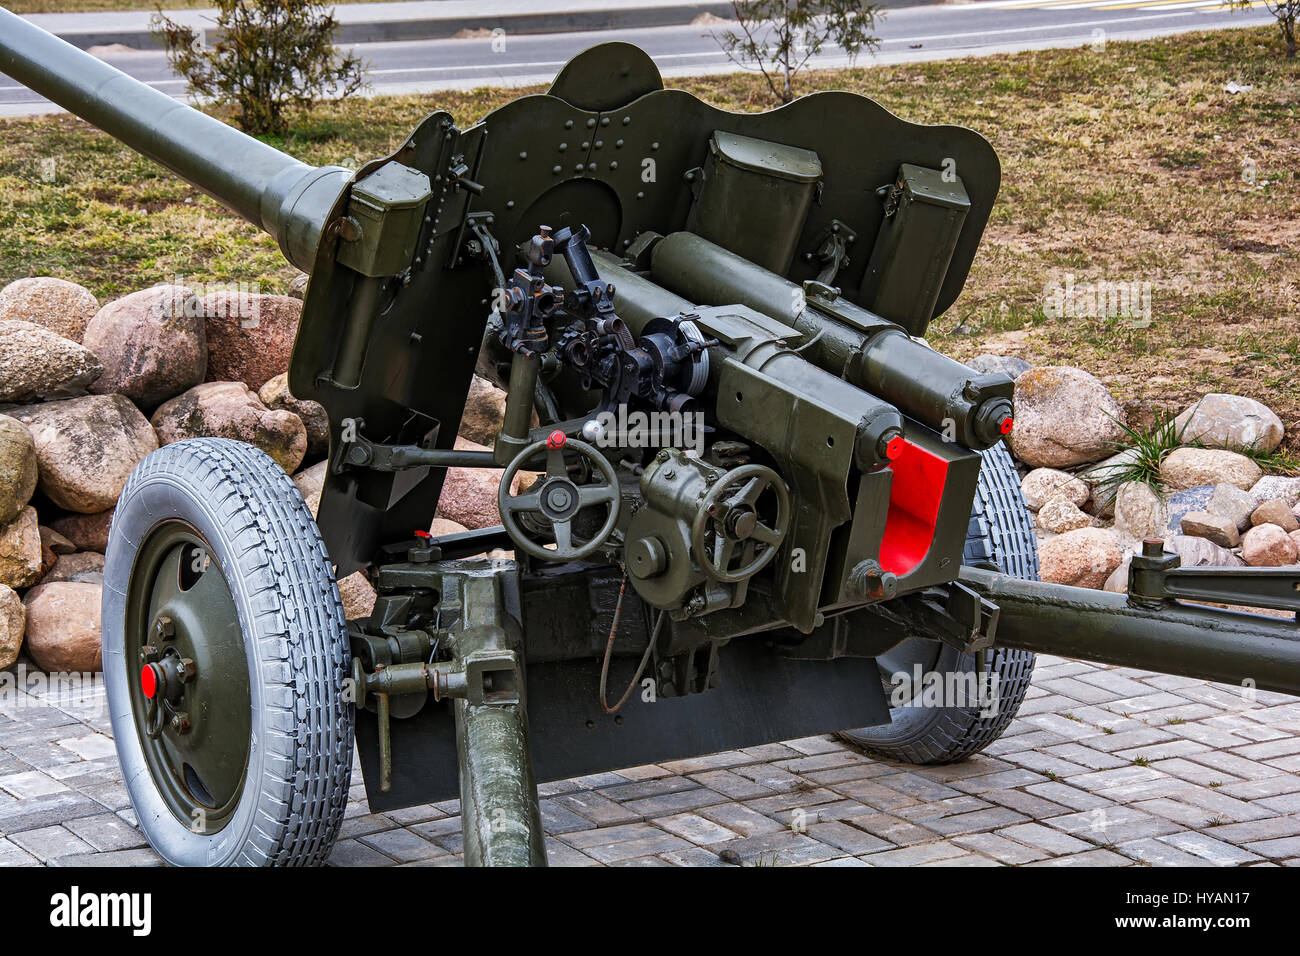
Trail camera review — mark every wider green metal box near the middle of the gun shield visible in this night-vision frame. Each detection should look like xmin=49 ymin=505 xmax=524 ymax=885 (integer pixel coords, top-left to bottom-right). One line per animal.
xmin=686 ymin=130 xmax=822 ymax=276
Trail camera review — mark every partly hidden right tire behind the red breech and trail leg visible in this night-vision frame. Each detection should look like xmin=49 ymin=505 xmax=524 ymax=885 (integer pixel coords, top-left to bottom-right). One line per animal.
xmin=841 ymin=442 xmax=1039 ymax=763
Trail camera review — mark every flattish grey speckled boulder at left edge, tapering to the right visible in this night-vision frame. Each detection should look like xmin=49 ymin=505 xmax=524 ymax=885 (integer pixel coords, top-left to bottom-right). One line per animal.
xmin=0 ymin=319 xmax=104 ymax=402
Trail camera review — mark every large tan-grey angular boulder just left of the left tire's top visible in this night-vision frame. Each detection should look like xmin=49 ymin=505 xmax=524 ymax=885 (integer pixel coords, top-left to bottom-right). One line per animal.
xmin=12 ymin=394 xmax=159 ymax=515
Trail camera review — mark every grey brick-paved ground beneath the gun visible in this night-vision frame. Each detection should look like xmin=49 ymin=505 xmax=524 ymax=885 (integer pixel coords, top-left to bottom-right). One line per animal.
xmin=0 ymin=657 xmax=1300 ymax=866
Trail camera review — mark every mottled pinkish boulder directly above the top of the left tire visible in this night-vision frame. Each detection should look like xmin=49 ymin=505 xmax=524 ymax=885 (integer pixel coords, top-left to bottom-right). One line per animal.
xmin=151 ymin=381 xmax=307 ymax=473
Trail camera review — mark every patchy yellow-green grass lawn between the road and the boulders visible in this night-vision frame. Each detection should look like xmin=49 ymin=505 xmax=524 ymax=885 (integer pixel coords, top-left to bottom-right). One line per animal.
xmin=0 ymin=27 xmax=1300 ymax=454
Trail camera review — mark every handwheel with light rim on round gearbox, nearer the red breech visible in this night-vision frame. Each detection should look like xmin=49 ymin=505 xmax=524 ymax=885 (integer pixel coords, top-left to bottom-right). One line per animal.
xmin=690 ymin=464 xmax=790 ymax=584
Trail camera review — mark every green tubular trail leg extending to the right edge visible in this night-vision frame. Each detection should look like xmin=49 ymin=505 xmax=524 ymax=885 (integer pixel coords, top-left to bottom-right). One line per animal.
xmin=961 ymin=567 xmax=1300 ymax=696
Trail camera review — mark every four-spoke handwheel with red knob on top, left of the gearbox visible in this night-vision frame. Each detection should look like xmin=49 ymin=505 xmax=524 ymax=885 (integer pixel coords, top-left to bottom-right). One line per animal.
xmin=497 ymin=431 xmax=620 ymax=561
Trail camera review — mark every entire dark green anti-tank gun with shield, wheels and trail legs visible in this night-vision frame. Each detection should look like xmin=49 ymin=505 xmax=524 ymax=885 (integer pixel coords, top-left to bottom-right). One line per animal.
xmin=0 ymin=18 xmax=1300 ymax=864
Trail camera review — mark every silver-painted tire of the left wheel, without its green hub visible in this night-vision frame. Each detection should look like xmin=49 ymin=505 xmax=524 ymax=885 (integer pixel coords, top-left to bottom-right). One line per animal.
xmin=101 ymin=438 xmax=354 ymax=866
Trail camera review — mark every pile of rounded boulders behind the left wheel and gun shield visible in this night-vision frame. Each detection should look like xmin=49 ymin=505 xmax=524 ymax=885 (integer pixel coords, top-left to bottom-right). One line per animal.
xmin=0 ymin=277 xmax=504 ymax=671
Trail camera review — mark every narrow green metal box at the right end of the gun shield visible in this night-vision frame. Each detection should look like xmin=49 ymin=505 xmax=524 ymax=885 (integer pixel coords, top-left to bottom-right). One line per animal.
xmin=859 ymin=163 xmax=971 ymax=336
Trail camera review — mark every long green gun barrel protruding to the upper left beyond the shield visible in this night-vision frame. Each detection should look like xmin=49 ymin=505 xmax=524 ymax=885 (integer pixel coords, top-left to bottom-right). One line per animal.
xmin=0 ymin=9 xmax=352 ymax=272
